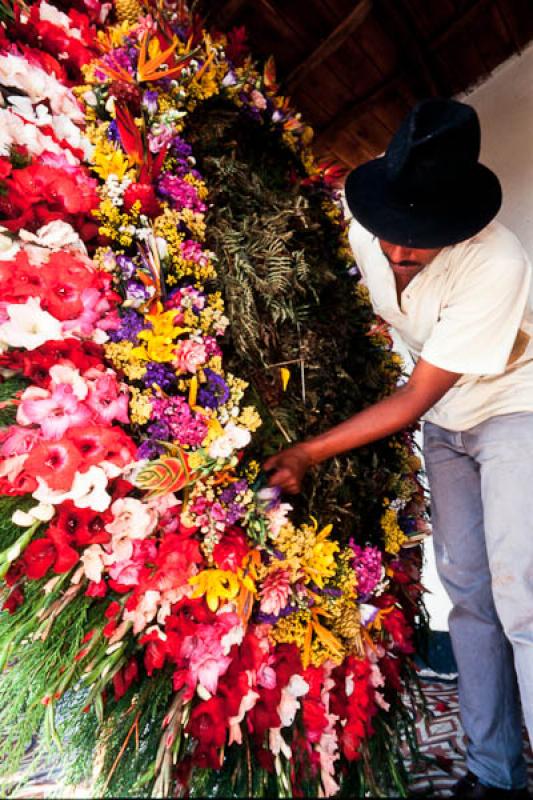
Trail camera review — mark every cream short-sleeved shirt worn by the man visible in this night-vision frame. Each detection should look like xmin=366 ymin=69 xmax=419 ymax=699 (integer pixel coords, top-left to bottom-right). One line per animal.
xmin=349 ymin=221 xmax=533 ymax=431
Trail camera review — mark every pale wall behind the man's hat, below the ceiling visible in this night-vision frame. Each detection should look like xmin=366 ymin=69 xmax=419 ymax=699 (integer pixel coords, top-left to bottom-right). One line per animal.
xmin=460 ymin=43 xmax=533 ymax=261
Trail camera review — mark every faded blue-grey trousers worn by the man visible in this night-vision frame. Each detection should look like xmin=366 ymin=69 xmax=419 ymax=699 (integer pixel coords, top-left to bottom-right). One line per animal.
xmin=424 ymin=412 xmax=533 ymax=789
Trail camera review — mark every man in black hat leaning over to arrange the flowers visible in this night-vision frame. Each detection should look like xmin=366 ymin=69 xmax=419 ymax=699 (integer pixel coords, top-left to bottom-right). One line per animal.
xmin=265 ymin=99 xmax=533 ymax=798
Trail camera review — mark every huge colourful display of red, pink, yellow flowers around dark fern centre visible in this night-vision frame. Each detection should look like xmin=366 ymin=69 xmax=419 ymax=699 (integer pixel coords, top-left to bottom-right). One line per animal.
xmin=0 ymin=0 xmax=423 ymax=796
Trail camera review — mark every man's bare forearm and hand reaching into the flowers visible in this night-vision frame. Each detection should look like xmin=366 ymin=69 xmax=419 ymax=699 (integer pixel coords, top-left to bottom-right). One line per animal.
xmin=265 ymin=359 xmax=461 ymax=494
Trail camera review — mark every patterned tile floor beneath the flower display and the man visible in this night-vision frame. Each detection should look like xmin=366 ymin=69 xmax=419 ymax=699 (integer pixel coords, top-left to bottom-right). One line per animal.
xmin=4 ymin=673 xmax=533 ymax=800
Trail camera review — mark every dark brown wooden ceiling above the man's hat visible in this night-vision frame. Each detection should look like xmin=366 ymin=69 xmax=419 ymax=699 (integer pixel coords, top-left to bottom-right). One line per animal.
xmin=197 ymin=0 xmax=533 ymax=166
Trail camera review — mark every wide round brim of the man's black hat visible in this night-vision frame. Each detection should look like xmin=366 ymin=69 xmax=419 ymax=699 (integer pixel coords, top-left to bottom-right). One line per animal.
xmin=345 ymin=157 xmax=502 ymax=248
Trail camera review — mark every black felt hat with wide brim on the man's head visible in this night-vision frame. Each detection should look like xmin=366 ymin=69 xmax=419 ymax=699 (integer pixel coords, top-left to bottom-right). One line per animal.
xmin=345 ymin=98 xmax=502 ymax=248
